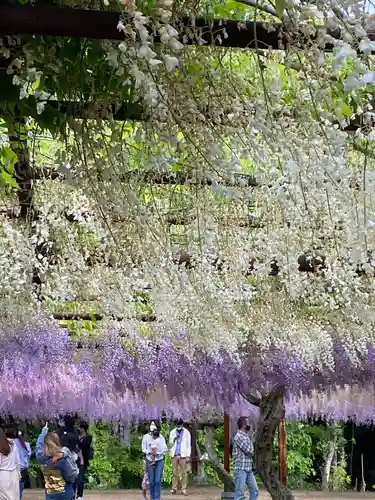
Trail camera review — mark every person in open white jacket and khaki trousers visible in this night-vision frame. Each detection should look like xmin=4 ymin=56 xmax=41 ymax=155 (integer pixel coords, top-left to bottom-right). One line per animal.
xmin=169 ymin=419 xmax=191 ymax=495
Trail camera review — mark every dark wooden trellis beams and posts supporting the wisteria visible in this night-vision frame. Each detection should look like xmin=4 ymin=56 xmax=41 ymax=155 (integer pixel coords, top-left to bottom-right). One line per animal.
xmin=0 ymin=2 xmax=374 ymax=484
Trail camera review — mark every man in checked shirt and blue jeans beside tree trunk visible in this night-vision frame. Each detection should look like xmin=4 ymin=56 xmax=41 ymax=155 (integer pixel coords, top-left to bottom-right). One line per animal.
xmin=233 ymin=417 xmax=259 ymax=500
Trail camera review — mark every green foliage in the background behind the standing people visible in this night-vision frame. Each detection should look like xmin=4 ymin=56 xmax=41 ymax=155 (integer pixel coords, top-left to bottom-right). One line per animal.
xmin=23 ymin=422 xmax=350 ymax=491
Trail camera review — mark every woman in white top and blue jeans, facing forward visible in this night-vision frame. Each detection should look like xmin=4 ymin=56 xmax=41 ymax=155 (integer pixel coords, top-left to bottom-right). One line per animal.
xmin=142 ymin=422 xmax=168 ymax=500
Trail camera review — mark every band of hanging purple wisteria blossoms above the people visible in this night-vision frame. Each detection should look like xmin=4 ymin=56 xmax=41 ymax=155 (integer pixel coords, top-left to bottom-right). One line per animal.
xmin=0 ymin=320 xmax=375 ymax=421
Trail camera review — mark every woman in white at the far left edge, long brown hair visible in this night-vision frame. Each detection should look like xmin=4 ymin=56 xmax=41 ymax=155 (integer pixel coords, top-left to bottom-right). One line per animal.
xmin=0 ymin=428 xmax=21 ymax=500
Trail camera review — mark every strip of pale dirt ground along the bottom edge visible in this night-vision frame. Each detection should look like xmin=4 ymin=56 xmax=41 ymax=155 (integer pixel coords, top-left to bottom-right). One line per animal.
xmin=24 ymin=488 xmax=375 ymax=500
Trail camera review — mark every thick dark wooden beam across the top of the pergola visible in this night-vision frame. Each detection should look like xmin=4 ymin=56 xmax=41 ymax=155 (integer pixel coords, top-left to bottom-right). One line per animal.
xmin=0 ymin=3 xmax=288 ymax=49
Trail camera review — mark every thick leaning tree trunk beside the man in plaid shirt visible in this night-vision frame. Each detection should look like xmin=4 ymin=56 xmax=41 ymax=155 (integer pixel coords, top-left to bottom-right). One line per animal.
xmin=254 ymin=387 xmax=294 ymax=500
